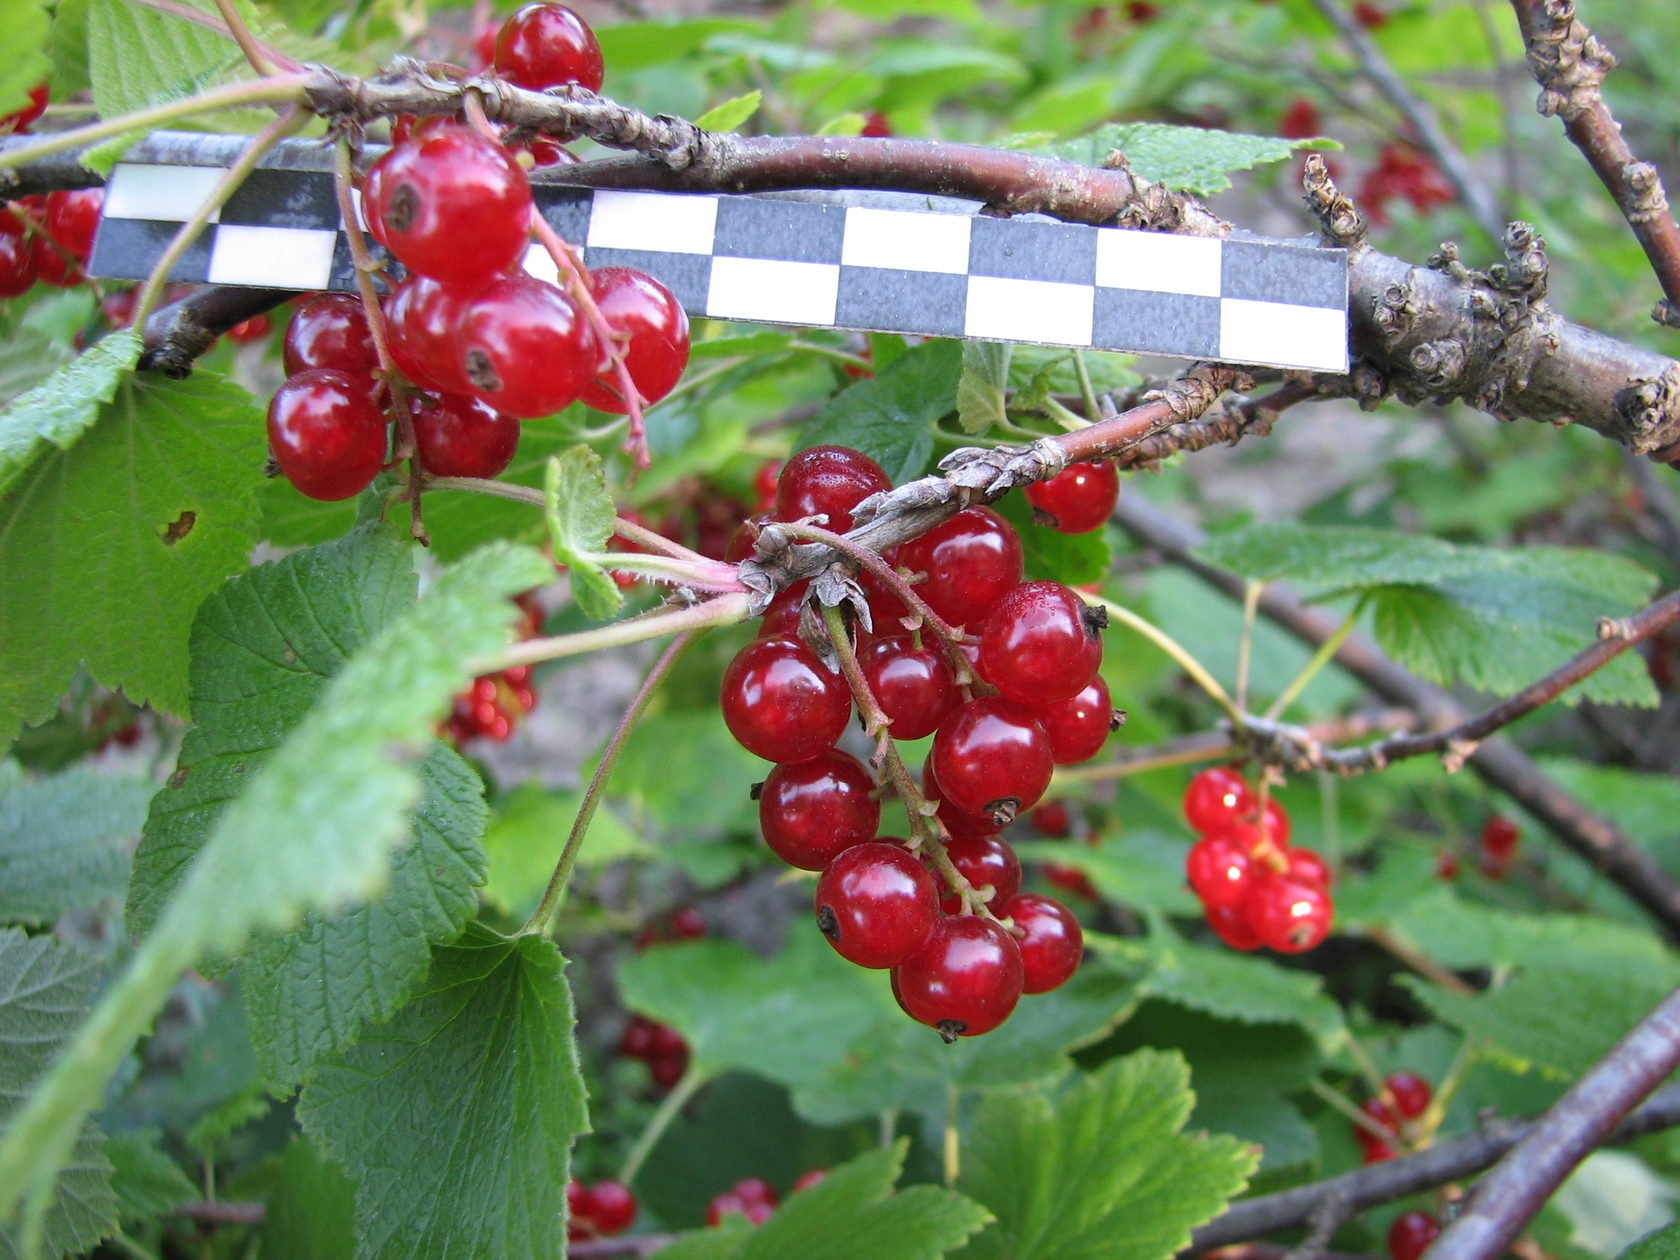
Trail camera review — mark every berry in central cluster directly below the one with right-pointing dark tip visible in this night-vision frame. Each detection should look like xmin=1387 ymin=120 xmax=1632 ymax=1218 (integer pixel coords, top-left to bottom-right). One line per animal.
xmin=931 ymin=696 xmax=1055 ymax=827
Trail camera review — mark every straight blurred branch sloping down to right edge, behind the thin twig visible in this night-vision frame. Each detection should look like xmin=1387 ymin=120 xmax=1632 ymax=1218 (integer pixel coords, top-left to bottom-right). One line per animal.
xmin=1114 ymin=496 xmax=1680 ymax=936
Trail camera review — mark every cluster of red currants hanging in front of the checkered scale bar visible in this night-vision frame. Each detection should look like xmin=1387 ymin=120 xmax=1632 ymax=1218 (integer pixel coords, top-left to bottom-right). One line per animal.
xmin=269 ymin=3 xmax=689 ymax=499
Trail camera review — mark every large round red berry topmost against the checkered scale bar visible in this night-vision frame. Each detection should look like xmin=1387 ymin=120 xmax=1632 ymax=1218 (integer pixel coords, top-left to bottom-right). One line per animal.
xmin=371 ymin=126 xmax=531 ymax=284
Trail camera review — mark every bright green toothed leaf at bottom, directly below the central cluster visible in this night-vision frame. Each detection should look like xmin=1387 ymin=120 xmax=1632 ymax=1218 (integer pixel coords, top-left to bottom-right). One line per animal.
xmin=958 ymin=1050 xmax=1258 ymax=1260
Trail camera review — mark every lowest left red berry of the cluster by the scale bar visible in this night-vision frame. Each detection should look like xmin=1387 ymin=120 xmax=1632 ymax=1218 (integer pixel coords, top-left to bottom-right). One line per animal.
xmin=269 ymin=368 xmax=386 ymax=501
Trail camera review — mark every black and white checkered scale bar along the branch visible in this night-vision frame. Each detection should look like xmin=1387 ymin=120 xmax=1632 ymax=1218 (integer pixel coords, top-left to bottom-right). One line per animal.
xmin=89 ymin=136 xmax=1347 ymax=371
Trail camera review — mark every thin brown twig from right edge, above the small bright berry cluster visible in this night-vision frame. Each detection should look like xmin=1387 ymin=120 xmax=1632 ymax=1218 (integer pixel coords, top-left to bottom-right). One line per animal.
xmin=1252 ymin=591 xmax=1680 ymax=774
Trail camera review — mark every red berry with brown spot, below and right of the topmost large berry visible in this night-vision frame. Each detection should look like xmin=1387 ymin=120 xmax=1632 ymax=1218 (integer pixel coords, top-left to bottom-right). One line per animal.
xmin=459 ymin=276 xmax=598 ymax=420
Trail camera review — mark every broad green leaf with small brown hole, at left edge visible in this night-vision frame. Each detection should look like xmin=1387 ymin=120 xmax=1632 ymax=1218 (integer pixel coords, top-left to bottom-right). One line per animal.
xmin=0 ymin=373 xmax=267 ymax=746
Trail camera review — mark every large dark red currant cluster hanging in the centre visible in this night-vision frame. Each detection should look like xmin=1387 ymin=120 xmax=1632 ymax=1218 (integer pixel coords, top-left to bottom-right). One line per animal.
xmin=722 ymin=447 xmax=1114 ymax=1040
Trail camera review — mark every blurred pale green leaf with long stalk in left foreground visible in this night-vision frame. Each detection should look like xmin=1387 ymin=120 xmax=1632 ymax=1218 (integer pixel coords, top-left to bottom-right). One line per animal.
xmin=0 ymin=548 xmax=548 ymax=1243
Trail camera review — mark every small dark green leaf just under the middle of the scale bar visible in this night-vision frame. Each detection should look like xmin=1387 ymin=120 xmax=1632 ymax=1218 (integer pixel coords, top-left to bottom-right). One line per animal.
xmin=798 ymin=341 xmax=963 ymax=486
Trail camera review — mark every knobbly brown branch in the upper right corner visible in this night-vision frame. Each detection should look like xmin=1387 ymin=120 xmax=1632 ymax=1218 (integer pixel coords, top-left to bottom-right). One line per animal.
xmin=1510 ymin=0 xmax=1680 ymax=328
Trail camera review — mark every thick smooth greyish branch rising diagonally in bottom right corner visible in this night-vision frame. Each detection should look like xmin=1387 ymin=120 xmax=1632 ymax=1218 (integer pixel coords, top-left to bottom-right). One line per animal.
xmin=1430 ymin=990 xmax=1680 ymax=1260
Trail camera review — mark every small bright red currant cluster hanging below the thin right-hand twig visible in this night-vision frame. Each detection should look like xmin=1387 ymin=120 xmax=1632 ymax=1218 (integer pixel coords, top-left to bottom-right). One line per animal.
xmin=1184 ymin=766 xmax=1334 ymax=954
